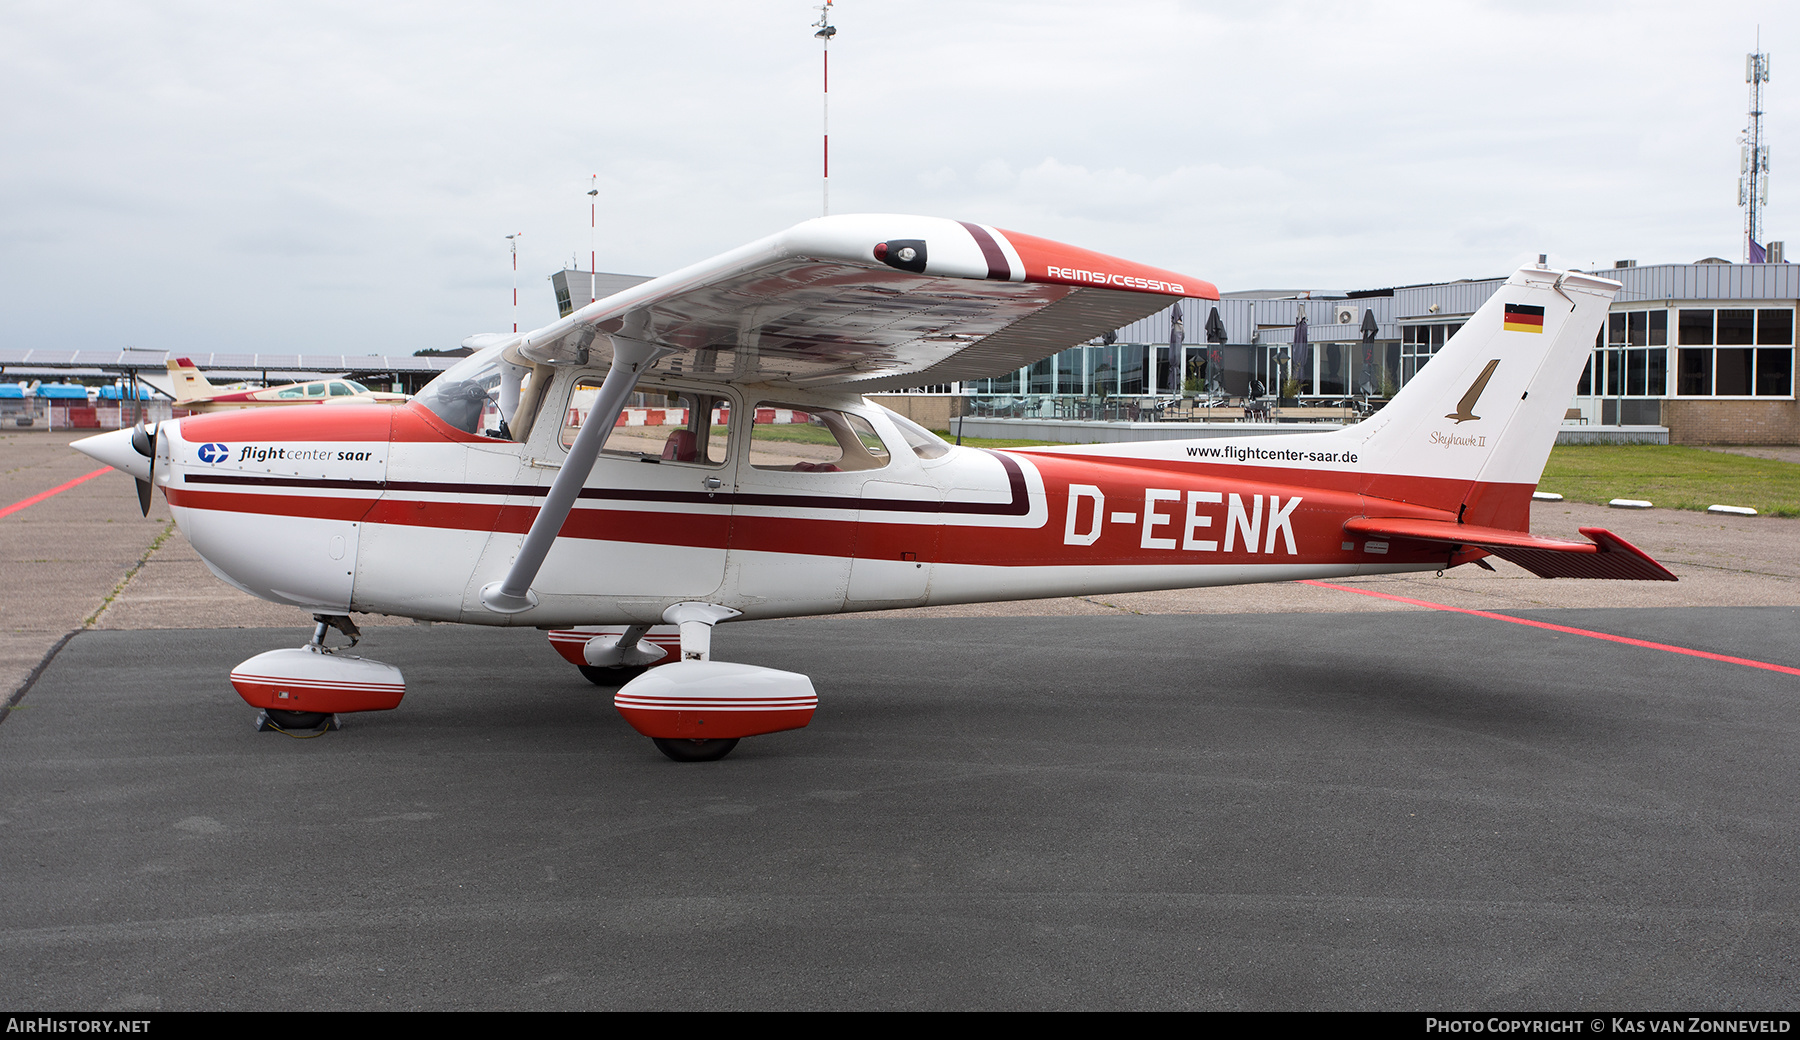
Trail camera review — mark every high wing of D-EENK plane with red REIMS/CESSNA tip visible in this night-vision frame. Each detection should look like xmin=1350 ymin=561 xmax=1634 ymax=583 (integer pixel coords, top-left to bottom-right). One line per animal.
xmin=500 ymin=214 xmax=1219 ymax=392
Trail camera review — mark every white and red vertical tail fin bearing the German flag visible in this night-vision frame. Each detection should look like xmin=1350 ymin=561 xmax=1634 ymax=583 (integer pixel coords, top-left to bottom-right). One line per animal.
xmin=1345 ymin=268 xmax=1620 ymax=531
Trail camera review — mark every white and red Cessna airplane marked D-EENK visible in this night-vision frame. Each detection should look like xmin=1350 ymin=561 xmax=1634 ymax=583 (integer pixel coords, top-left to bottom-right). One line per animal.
xmin=77 ymin=216 xmax=1674 ymax=761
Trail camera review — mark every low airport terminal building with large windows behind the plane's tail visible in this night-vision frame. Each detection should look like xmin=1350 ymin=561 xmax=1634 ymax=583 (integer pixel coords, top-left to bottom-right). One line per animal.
xmin=931 ymin=259 xmax=1800 ymax=444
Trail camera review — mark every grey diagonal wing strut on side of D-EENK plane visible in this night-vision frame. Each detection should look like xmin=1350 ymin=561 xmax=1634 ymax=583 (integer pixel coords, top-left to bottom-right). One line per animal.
xmin=481 ymin=336 xmax=673 ymax=614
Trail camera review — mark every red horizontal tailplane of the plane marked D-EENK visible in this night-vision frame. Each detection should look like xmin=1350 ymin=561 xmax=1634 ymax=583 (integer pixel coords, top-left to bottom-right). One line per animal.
xmin=1345 ymin=516 xmax=1676 ymax=581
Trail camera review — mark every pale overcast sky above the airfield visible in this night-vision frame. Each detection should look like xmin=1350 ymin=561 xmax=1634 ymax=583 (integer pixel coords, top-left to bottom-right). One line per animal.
xmin=0 ymin=0 xmax=1800 ymax=354
